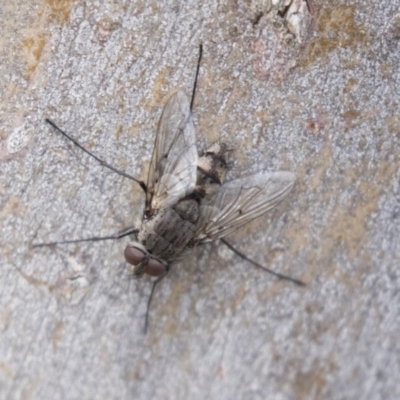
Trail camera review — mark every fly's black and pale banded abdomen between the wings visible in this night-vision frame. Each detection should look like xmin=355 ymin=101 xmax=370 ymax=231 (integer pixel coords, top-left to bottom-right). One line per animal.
xmin=194 ymin=142 xmax=228 ymax=198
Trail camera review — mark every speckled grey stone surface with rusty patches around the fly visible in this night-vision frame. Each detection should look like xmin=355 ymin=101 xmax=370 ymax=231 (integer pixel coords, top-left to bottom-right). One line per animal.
xmin=0 ymin=0 xmax=400 ymax=400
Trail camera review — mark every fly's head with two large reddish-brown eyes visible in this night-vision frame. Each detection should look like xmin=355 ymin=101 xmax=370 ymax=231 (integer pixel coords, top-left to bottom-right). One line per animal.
xmin=124 ymin=243 xmax=168 ymax=278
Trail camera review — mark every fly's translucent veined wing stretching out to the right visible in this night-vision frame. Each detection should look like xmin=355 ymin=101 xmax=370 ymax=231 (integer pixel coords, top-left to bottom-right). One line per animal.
xmin=195 ymin=172 xmax=295 ymax=244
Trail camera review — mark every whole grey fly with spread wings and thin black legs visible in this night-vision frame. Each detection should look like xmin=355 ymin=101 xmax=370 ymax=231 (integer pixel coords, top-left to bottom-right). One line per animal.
xmin=34 ymin=46 xmax=304 ymax=331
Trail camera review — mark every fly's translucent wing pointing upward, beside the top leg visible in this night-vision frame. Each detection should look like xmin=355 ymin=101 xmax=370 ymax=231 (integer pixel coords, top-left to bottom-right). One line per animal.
xmin=146 ymin=91 xmax=198 ymax=210
